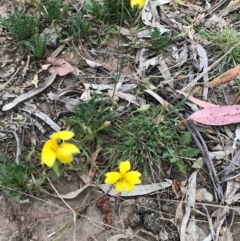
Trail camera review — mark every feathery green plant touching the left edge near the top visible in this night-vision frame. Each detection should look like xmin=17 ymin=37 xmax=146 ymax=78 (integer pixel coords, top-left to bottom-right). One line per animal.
xmin=0 ymin=11 xmax=39 ymax=42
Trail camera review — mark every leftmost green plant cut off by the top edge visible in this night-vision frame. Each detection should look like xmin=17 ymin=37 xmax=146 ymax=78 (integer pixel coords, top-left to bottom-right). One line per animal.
xmin=35 ymin=0 xmax=62 ymax=22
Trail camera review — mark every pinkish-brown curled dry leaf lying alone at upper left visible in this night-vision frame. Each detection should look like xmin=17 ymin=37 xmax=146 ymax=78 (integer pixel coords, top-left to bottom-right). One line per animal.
xmin=47 ymin=57 xmax=75 ymax=76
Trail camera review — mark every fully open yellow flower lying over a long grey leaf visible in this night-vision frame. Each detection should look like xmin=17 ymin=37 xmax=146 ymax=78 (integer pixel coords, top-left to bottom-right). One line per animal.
xmin=105 ymin=161 xmax=141 ymax=192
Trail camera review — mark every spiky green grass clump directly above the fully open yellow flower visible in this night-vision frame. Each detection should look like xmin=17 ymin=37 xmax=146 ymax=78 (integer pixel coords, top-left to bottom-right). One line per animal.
xmin=109 ymin=110 xmax=198 ymax=172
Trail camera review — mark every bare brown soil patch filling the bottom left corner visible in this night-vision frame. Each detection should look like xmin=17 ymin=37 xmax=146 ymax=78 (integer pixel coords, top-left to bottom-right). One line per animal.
xmin=0 ymin=181 xmax=125 ymax=241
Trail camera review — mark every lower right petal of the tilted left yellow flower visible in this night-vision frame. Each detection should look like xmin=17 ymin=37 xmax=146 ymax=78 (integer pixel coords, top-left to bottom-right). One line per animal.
xmin=56 ymin=143 xmax=79 ymax=163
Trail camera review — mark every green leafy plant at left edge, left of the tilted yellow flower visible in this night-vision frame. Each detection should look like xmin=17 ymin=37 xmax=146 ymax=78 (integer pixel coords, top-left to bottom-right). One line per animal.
xmin=0 ymin=152 xmax=34 ymax=199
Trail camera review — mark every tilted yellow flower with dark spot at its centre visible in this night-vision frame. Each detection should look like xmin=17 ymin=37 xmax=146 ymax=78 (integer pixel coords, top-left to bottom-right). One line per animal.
xmin=41 ymin=131 xmax=80 ymax=167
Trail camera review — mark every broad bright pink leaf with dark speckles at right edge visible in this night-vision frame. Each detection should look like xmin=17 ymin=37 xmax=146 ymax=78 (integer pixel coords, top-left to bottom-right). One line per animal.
xmin=188 ymin=105 xmax=240 ymax=126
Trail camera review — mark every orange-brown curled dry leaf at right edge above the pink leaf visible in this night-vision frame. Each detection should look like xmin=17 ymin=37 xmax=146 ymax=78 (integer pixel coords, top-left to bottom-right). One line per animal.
xmin=204 ymin=65 xmax=240 ymax=88
